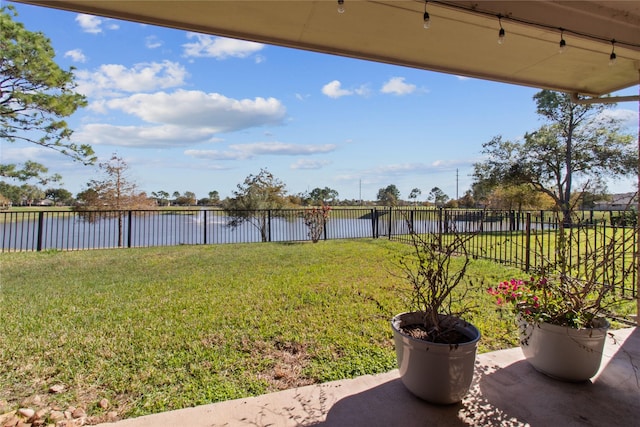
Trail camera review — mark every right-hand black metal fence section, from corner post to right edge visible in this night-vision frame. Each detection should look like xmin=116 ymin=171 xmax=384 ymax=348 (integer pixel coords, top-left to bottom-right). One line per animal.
xmin=388 ymin=209 xmax=638 ymax=298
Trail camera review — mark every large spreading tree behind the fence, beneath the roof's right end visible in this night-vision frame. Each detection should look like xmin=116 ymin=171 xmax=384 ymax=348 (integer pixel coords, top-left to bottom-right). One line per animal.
xmin=474 ymin=90 xmax=638 ymax=222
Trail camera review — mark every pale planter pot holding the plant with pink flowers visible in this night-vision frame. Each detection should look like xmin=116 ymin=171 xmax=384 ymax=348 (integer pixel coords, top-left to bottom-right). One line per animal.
xmin=518 ymin=316 xmax=609 ymax=382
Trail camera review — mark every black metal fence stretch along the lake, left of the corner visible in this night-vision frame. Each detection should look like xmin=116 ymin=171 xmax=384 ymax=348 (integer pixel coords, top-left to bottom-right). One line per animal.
xmin=0 ymin=208 xmax=386 ymax=252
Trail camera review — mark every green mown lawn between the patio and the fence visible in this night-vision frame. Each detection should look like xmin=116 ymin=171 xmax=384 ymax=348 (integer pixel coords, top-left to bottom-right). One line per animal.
xmin=0 ymin=239 xmax=632 ymax=420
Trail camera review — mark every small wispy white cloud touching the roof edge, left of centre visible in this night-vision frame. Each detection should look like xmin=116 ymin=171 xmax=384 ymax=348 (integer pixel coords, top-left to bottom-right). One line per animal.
xmin=182 ymin=33 xmax=265 ymax=62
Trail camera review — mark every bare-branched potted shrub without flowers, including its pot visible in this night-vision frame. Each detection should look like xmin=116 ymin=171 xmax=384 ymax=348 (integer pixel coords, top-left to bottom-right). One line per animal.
xmin=391 ymin=222 xmax=480 ymax=404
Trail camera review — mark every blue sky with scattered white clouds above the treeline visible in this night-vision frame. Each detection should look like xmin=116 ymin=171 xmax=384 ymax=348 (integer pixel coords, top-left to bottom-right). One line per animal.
xmin=1 ymin=4 xmax=638 ymax=200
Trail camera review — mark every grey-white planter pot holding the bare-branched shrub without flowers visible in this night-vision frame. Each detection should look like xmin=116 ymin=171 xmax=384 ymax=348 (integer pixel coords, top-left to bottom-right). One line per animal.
xmin=391 ymin=312 xmax=480 ymax=404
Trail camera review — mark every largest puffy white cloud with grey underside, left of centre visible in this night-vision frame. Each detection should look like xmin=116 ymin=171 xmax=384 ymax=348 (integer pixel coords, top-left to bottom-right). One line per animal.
xmin=106 ymin=90 xmax=286 ymax=132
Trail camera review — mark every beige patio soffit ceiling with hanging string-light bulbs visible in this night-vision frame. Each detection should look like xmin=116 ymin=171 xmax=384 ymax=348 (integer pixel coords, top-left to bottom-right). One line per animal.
xmin=10 ymin=0 xmax=640 ymax=96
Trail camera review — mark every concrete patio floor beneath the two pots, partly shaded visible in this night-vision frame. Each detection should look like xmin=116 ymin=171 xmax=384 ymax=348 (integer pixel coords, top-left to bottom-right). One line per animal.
xmin=100 ymin=328 xmax=640 ymax=427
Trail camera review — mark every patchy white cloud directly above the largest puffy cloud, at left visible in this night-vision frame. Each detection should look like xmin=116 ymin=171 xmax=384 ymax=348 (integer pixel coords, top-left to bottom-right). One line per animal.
xmin=76 ymin=61 xmax=188 ymax=96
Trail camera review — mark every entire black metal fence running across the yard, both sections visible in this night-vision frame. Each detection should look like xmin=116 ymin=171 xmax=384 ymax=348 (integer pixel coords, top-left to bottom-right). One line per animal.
xmin=0 ymin=208 xmax=637 ymax=296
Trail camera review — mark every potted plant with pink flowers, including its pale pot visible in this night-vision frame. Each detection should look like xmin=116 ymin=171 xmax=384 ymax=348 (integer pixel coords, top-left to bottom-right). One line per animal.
xmin=488 ymin=214 xmax=635 ymax=382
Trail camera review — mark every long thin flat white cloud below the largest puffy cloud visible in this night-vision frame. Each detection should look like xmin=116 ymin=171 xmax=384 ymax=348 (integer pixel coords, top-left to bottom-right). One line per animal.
xmin=185 ymin=142 xmax=336 ymax=160
